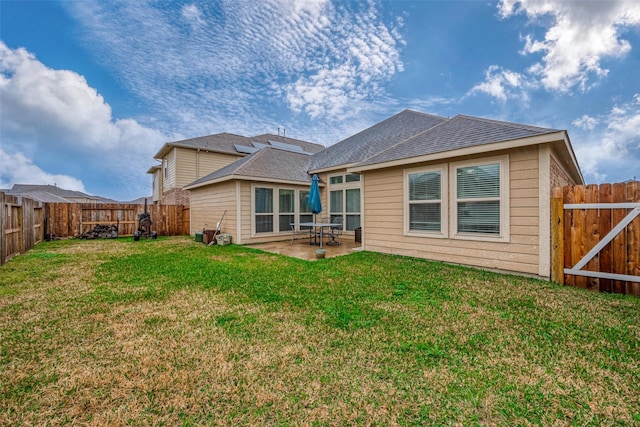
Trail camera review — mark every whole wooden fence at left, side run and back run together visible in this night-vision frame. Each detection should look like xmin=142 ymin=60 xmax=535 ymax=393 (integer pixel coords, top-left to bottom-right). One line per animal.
xmin=0 ymin=192 xmax=190 ymax=265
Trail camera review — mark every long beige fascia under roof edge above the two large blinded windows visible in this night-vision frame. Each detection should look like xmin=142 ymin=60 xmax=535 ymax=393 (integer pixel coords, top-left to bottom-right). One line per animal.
xmin=347 ymin=131 xmax=568 ymax=173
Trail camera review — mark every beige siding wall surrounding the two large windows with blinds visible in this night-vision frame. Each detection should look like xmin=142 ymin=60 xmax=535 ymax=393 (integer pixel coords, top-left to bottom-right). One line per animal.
xmin=363 ymin=147 xmax=539 ymax=274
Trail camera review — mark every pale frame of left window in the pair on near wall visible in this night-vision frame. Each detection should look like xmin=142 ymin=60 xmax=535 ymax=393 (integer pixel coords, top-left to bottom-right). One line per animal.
xmin=403 ymin=164 xmax=449 ymax=239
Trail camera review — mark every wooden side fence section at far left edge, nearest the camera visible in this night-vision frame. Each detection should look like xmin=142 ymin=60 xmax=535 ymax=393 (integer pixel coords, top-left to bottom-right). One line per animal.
xmin=0 ymin=192 xmax=43 ymax=265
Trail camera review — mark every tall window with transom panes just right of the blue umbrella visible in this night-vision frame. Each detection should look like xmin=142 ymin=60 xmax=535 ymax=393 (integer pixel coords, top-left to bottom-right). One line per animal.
xmin=329 ymin=173 xmax=362 ymax=231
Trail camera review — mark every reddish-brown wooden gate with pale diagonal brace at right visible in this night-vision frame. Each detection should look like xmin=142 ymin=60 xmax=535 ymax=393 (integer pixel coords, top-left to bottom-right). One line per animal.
xmin=551 ymin=181 xmax=640 ymax=296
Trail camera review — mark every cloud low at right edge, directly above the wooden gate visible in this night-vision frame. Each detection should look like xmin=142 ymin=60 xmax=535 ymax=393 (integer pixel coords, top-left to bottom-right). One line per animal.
xmin=573 ymin=95 xmax=640 ymax=182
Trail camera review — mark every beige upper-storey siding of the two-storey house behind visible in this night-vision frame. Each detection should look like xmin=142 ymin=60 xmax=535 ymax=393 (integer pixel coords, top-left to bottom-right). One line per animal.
xmin=174 ymin=148 xmax=240 ymax=188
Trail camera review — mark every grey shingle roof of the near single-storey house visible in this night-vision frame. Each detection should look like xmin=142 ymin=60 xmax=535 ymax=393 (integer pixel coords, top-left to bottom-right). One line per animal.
xmin=180 ymin=110 xmax=559 ymax=188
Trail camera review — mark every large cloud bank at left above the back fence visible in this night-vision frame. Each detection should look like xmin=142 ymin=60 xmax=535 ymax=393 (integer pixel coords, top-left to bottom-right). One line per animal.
xmin=0 ymin=42 xmax=166 ymax=198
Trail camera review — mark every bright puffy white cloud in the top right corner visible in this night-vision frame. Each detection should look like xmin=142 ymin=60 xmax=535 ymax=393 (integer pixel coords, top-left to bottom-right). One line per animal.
xmin=498 ymin=0 xmax=640 ymax=92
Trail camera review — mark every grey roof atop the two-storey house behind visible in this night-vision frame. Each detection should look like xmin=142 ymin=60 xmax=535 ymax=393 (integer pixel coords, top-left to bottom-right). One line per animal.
xmin=153 ymin=132 xmax=324 ymax=160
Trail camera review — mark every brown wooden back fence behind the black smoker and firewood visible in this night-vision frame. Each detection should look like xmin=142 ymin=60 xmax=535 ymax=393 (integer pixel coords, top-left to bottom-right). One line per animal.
xmin=45 ymin=203 xmax=189 ymax=238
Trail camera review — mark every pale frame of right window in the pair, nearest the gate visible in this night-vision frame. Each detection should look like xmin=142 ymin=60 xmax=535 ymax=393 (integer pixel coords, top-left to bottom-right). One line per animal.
xmin=449 ymin=154 xmax=510 ymax=242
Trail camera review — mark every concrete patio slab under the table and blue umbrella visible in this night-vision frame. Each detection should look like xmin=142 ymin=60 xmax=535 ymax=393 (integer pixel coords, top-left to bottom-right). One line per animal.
xmin=247 ymin=235 xmax=362 ymax=261
